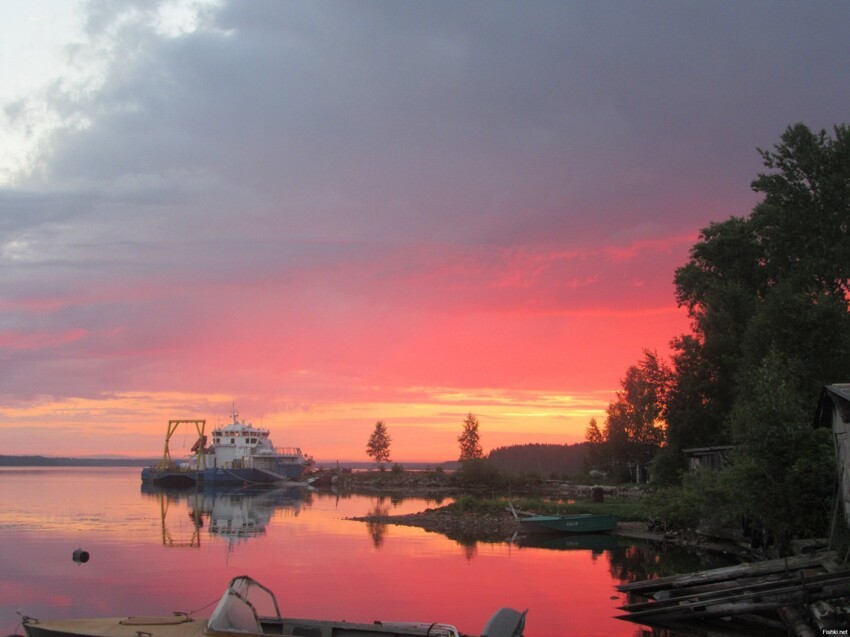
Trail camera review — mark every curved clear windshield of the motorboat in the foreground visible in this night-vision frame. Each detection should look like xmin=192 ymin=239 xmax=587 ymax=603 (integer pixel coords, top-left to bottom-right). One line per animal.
xmin=207 ymin=575 xmax=280 ymax=634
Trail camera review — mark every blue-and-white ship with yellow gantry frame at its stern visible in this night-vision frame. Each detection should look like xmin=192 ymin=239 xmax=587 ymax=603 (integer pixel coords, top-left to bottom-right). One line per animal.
xmin=142 ymin=408 xmax=313 ymax=487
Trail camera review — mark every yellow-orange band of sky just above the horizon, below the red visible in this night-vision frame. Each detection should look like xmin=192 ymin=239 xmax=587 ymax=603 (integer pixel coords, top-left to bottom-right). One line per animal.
xmin=0 ymin=388 xmax=612 ymax=463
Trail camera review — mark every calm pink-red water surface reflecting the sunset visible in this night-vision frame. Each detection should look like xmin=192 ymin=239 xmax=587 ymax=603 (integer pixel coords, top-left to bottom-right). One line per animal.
xmin=0 ymin=468 xmax=728 ymax=637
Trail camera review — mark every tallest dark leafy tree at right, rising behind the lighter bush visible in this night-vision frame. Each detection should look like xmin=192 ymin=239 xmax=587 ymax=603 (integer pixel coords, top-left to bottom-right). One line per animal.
xmin=666 ymin=124 xmax=850 ymax=458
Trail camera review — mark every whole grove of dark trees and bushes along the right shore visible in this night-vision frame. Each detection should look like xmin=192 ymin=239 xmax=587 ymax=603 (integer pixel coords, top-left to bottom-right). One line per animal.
xmin=586 ymin=124 xmax=850 ymax=548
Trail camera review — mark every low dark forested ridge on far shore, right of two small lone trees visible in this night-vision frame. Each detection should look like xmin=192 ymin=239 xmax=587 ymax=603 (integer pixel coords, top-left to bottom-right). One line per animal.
xmin=487 ymin=442 xmax=590 ymax=477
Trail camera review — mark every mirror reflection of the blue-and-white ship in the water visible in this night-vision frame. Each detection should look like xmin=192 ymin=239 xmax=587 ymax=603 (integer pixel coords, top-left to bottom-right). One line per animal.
xmin=142 ymin=483 xmax=312 ymax=547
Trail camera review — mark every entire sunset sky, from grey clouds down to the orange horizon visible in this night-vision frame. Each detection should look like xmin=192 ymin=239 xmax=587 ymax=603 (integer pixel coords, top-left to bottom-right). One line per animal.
xmin=0 ymin=0 xmax=850 ymax=462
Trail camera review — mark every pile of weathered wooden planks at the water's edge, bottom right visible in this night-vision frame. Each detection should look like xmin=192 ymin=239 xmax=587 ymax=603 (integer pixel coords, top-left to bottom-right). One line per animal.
xmin=617 ymin=551 xmax=850 ymax=637
